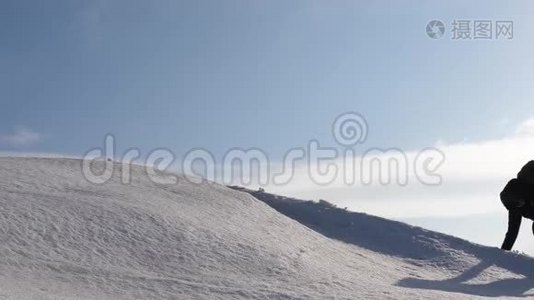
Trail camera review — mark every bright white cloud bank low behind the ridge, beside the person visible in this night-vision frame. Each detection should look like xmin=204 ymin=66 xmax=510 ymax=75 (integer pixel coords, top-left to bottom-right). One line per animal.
xmin=267 ymin=118 xmax=534 ymax=218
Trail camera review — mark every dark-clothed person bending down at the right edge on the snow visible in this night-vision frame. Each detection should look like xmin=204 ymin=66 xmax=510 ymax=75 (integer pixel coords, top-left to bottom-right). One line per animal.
xmin=500 ymin=160 xmax=534 ymax=250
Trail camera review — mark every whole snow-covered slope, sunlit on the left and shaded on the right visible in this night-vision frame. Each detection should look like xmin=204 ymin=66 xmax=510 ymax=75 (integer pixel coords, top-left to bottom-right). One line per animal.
xmin=0 ymin=158 xmax=534 ymax=299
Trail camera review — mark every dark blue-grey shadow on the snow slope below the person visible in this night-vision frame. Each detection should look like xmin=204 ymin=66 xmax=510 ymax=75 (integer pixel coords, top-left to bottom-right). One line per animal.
xmin=231 ymin=186 xmax=534 ymax=297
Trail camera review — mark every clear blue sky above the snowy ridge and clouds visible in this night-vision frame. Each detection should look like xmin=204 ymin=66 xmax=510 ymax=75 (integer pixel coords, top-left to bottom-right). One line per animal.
xmin=0 ymin=0 xmax=534 ymax=253
